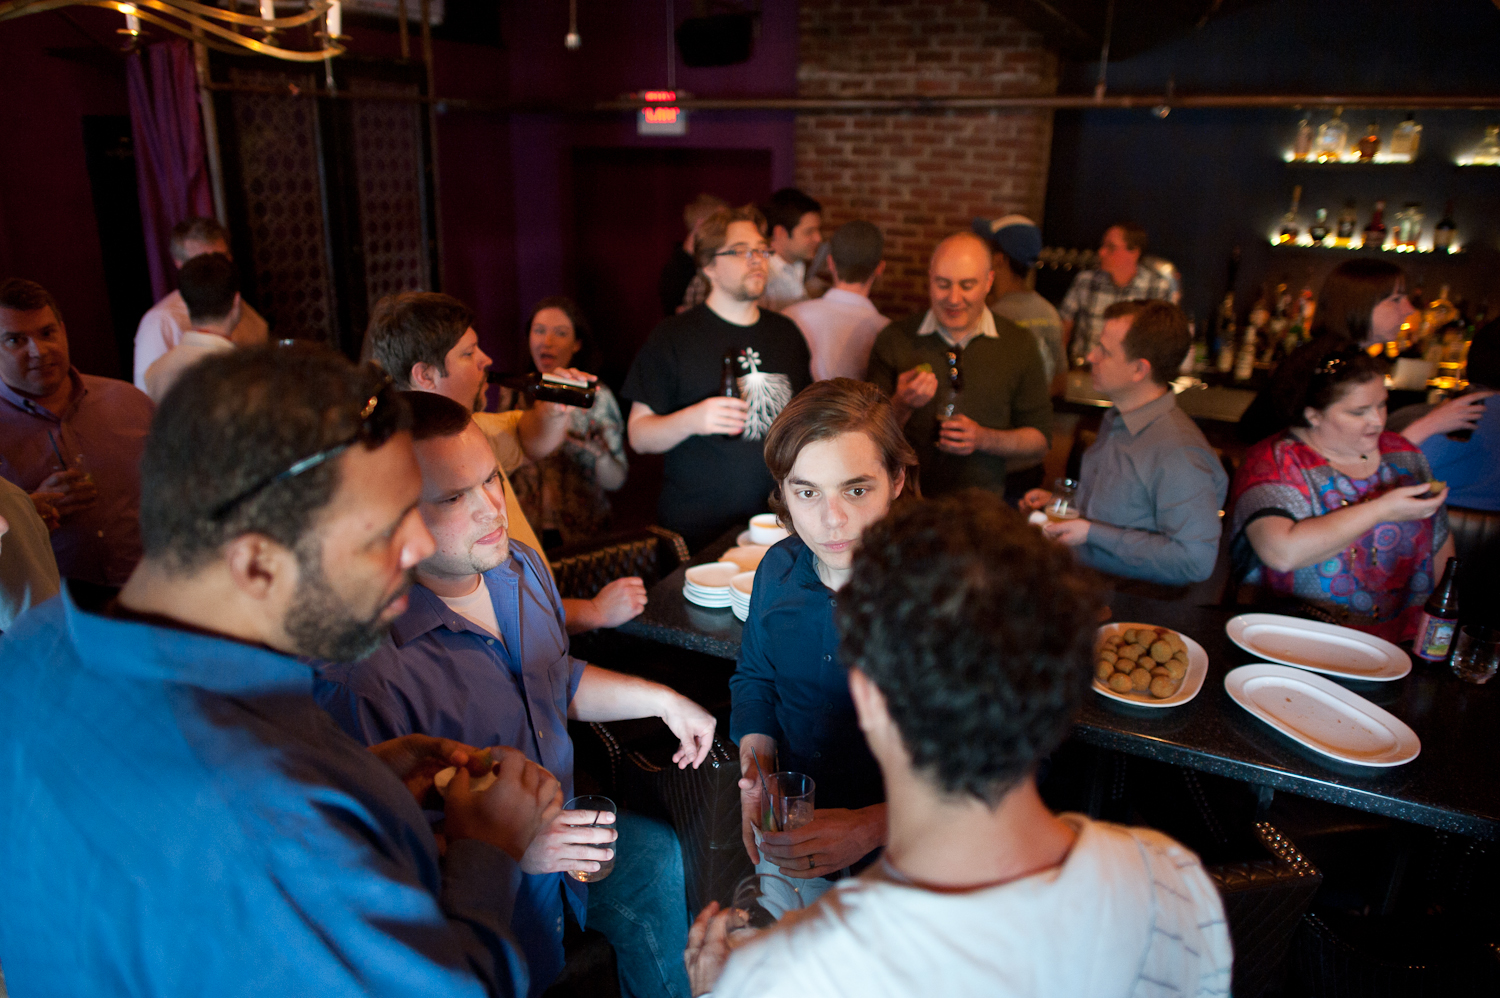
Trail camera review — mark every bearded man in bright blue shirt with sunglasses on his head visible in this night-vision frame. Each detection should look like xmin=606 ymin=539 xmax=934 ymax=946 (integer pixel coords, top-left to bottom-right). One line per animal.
xmin=0 ymin=348 xmax=561 ymax=998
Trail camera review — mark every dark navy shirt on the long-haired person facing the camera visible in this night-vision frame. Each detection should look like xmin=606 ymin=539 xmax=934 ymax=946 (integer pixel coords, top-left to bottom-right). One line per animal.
xmin=729 ymin=534 xmax=885 ymax=807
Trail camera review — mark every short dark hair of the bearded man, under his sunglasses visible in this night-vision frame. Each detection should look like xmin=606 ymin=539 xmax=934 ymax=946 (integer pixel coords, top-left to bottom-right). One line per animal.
xmin=141 ymin=342 xmax=411 ymax=572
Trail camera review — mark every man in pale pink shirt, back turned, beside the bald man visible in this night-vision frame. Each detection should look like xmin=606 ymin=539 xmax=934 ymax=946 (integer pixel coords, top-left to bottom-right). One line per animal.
xmin=782 ymin=221 xmax=891 ymax=381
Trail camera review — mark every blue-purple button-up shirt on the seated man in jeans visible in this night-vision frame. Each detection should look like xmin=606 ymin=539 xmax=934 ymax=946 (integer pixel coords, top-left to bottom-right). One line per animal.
xmin=317 ymin=540 xmax=588 ymax=993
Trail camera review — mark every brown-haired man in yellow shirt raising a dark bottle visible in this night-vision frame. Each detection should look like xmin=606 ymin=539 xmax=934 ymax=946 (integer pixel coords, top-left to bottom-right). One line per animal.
xmin=365 ymin=291 xmax=647 ymax=635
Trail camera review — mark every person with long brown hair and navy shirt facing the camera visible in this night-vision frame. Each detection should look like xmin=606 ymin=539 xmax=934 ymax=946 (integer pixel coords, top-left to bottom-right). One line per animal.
xmin=729 ymin=378 xmax=920 ymax=903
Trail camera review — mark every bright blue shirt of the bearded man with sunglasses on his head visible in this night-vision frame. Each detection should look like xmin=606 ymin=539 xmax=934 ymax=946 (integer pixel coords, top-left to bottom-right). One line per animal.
xmin=0 ymin=588 xmax=527 ymax=996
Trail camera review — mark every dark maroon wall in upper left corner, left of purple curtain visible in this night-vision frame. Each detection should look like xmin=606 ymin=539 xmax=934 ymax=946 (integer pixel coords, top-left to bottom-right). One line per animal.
xmin=0 ymin=8 xmax=129 ymax=377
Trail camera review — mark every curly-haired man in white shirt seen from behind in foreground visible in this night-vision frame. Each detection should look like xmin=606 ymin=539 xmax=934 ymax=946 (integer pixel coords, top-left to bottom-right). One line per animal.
xmin=686 ymin=489 xmax=1230 ymax=998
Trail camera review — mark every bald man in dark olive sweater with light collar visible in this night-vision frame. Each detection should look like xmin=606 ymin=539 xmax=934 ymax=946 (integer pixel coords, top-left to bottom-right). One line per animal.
xmin=869 ymin=233 xmax=1052 ymax=501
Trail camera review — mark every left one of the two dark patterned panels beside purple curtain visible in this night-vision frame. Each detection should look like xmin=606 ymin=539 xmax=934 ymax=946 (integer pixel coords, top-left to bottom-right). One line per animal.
xmin=230 ymin=69 xmax=338 ymax=345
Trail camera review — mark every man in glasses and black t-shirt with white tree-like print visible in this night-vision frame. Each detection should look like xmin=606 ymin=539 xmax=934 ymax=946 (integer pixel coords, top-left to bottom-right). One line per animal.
xmin=621 ymin=206 xmax=812 ymax=549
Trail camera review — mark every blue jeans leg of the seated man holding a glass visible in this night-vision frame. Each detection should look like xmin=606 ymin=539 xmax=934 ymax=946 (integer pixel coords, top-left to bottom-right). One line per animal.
xmin=588 ymin=812 xmax=692 ymax=998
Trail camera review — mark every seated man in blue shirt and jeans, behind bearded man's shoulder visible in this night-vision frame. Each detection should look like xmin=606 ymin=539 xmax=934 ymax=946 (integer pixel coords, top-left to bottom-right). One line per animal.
xmin=317 ymin=392 xmax=714 ymax=998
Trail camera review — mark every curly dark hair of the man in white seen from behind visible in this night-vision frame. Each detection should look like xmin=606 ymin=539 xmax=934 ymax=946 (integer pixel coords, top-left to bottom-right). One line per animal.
xmin=836 ymin=489 xmax=1104 ymax=807
